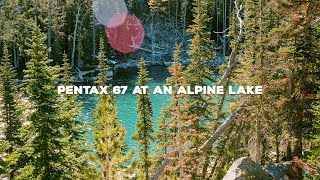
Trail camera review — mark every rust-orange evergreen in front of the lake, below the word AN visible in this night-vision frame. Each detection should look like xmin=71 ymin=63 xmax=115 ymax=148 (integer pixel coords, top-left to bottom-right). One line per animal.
xmin=154 ymin=44 xmax=187 ymax=179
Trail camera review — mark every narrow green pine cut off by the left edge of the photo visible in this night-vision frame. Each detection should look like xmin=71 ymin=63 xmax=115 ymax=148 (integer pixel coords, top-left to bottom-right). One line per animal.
xmin=0 ymin=46 xmax=22 ymax=179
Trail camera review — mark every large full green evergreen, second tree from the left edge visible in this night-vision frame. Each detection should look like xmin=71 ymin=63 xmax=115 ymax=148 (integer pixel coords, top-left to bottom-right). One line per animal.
xmin=19 ymin=24 xmax=63 ymax=179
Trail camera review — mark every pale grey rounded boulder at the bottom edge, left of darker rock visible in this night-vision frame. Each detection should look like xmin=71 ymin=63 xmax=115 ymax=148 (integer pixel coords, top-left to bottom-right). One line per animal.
xmin=223 ymin=157 xmax=273 ymax=180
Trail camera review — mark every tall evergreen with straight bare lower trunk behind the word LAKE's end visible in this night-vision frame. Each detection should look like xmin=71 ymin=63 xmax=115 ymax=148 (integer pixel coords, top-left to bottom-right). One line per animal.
xmin=235 ymin=0 xmax=272 ymax=163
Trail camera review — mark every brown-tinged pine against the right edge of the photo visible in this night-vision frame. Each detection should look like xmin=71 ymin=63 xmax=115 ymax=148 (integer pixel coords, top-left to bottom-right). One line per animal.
xmin=273 ymin=0 xmax=320 ymax=159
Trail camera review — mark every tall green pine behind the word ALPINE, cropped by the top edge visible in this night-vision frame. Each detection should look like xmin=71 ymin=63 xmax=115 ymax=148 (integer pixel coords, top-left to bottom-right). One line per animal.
xmin=185 ymin=0 xmax=215 ymax=122
